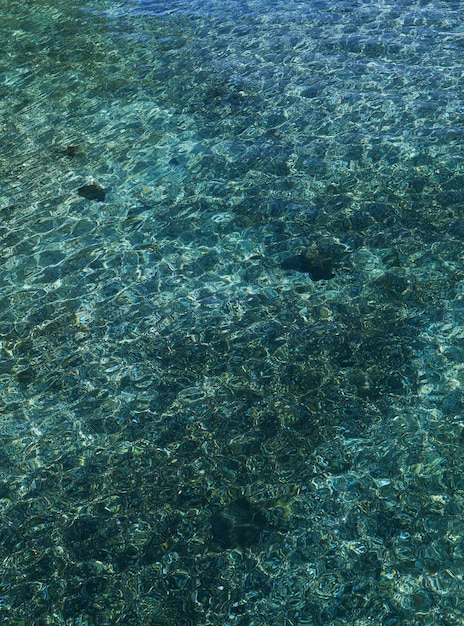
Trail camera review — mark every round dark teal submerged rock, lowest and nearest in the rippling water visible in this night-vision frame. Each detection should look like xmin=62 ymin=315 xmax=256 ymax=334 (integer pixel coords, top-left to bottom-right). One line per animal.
xmin=211 ymin=498 xmax=267 ymax=548
